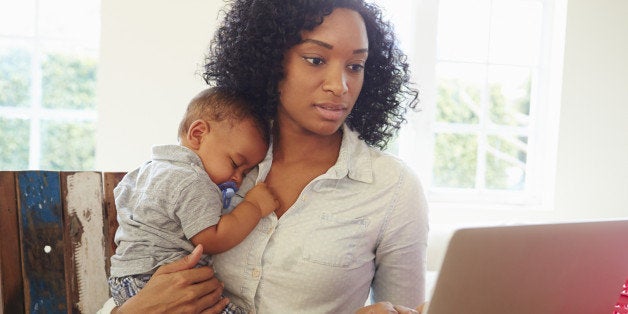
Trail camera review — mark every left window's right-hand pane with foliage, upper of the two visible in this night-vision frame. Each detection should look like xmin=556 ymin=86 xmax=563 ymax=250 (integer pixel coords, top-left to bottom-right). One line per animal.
xmin=42 ymin=53 xmax=96 ymax=109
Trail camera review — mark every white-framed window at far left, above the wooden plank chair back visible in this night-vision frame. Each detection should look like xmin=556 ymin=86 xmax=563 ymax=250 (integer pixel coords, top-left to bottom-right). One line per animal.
xmin=0 ymin=0 xmax=100 ymax=170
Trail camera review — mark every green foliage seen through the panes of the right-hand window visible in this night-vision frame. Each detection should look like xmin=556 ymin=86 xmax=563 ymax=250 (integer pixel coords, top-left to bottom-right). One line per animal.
xmin=433 ymin=79 xmax=531 ymax=190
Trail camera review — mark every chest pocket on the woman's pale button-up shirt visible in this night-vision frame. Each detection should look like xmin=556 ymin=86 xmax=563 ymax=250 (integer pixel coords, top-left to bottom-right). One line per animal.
xmin=303 ymin=212 xmax=369 ymax=268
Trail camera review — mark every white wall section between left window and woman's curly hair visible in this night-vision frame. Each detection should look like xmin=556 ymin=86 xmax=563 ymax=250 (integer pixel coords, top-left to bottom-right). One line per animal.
xmin=96 ymin=0 xmax=222 ymax=171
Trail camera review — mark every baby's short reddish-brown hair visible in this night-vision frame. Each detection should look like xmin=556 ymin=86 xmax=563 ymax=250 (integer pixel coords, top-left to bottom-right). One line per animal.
xmin=178 ymin=87 xmax=270 ymax=144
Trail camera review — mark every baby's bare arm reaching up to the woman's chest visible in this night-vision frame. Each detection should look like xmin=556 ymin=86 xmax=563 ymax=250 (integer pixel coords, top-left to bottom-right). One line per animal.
xmin=191 ymin=183 xmax=279 ymax=254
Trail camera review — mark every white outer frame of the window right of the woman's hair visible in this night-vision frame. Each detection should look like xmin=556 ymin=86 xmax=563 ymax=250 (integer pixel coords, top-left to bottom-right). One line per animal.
xmin=379 ymin=0 xmax=567 ymax=215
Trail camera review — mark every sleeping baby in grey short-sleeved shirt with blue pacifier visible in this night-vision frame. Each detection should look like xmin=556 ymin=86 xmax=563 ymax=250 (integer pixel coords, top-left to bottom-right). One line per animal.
xmin=109 ymin=87 xmax=279 ymax=313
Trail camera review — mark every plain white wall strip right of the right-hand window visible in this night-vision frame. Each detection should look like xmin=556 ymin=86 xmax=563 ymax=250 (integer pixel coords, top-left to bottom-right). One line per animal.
xmin=555 ymin=0 xmax=628 ymax=219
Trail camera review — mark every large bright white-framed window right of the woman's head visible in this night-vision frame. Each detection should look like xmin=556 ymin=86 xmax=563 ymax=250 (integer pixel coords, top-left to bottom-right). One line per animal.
xmin=378 ymin=0 xmax=566 ymax=209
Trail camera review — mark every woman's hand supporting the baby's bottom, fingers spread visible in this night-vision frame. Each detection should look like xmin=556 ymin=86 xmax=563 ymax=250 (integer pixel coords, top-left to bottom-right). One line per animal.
xmin=112 ymin=245 xmax=229 ymax=313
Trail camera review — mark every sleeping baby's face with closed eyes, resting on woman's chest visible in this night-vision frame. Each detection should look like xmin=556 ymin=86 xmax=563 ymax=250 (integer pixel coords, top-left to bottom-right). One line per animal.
xmin=198 ymin=119 xmax=268 ymax=187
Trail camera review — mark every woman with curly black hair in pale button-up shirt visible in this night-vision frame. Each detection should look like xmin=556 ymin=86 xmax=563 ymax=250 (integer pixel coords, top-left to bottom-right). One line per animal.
xmin=103 ymin=0 xmax=428 ymax=313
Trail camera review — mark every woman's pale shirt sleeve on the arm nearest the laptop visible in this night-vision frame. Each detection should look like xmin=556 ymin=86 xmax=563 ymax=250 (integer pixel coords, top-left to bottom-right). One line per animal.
xmin=372 ymin=167 xmax=429 ymax=308
